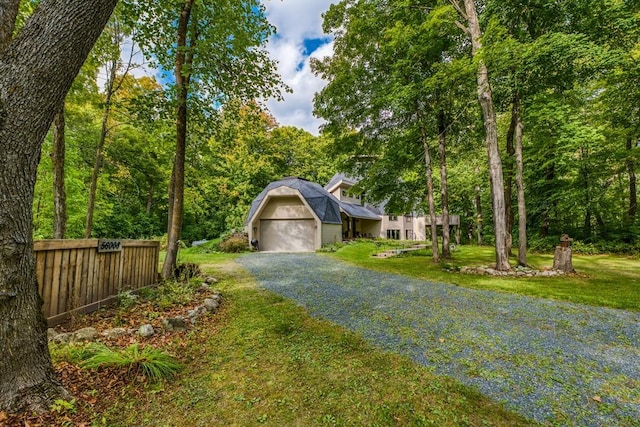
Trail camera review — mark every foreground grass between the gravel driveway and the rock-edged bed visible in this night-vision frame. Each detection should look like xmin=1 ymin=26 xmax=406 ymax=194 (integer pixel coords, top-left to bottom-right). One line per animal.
xmin=104 ymin=255 xmax=532 ymax=426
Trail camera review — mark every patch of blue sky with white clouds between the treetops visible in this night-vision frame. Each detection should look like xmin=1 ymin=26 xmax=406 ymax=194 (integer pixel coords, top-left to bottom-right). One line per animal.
xmin=262 ymin=0 xmax=338 ymax=135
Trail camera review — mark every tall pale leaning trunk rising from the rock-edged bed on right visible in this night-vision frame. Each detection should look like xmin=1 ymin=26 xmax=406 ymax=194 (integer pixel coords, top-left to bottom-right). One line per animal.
xmin=464 ymin=0 xmax=511 ymax=271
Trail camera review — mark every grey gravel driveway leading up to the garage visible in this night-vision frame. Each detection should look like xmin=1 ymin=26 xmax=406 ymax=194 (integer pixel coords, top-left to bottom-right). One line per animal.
xmin=237 ymin=254 xmax=640 ymax=426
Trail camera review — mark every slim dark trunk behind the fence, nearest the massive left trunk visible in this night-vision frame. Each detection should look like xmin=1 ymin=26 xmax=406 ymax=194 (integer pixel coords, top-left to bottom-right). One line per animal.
xmin=51 ymin=103 xmax=67 ymax=239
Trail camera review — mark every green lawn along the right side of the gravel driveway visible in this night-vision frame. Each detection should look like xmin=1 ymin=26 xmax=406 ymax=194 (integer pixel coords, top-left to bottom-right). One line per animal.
xmin=327 ymin=241 xmax=640 ymax=311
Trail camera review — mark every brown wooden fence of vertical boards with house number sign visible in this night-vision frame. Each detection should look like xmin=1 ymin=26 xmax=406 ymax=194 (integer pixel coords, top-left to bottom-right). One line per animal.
xmin=34 ymin=239 xmax=160 ymax=326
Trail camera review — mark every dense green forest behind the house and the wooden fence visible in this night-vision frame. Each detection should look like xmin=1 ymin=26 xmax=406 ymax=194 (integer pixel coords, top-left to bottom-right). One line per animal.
xmin=33 ymin=0 xmax=640 ymax=258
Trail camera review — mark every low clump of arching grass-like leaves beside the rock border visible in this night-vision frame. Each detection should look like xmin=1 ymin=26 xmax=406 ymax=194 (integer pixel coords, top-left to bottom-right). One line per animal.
xmin=81 ymin=343 xmax=182 ymax=381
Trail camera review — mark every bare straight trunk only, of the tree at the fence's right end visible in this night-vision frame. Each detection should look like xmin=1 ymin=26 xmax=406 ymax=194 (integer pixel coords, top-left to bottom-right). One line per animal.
xmin=162 ymin=0 xmax=193 ymax=279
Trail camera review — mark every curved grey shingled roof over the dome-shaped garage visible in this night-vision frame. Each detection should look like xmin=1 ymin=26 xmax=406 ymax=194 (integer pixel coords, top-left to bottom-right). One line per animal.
xmin=245 ymin=177 xmax=342 ymax=224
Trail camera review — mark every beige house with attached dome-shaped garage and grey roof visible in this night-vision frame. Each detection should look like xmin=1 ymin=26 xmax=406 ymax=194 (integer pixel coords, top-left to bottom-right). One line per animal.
xmin=245 ymin=174 xmax=425 ymax=252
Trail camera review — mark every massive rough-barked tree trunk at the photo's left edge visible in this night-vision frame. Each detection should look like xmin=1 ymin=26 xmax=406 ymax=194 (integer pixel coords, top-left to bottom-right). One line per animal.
xmin=0 ymin=0 xmax=116 ymax=412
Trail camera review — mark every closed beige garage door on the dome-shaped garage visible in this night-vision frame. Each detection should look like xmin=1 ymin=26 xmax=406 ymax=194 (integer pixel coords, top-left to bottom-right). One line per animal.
xmin=260 ymin=219 xmax=316 ymax=252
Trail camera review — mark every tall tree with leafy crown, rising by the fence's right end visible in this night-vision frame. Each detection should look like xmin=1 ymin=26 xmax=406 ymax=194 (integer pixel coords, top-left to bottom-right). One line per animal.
xmin=132 ymin=0 xmax=280 ymax=278
